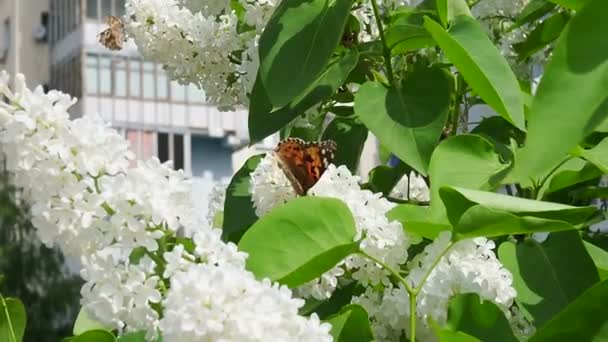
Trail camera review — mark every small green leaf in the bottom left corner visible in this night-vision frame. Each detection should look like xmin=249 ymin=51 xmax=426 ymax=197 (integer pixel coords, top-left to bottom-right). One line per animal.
xmin=0 ymin=295 xmax=27 ymax=342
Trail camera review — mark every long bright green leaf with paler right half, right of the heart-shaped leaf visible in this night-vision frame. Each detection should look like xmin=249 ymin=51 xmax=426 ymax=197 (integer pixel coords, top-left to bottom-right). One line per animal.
xmin=424 ymin=15 xmax=526 ymax=131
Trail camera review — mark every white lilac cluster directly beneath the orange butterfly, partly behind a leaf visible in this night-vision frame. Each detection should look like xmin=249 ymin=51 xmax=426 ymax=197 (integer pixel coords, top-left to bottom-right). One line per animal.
xmin=251 ymin=153 xmax=411 ymax=299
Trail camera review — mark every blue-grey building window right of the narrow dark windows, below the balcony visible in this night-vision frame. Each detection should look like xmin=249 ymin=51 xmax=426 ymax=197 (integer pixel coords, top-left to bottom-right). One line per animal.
xmin=191 ymin=135 xmax=232 ymax=179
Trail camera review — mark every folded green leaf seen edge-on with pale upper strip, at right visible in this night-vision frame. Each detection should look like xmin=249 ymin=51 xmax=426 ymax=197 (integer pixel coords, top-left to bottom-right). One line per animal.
xmin=439 ymin=186 xmax=597 ymax=228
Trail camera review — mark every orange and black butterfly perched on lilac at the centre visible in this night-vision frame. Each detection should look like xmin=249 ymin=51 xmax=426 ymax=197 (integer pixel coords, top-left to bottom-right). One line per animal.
xmin=274 ymin=138 xmax=337 ymax=196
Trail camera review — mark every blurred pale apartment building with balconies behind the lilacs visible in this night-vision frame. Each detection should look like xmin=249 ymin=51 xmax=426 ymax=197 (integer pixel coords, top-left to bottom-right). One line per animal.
xmin=0 ymin=0 xmax=378 ymax=211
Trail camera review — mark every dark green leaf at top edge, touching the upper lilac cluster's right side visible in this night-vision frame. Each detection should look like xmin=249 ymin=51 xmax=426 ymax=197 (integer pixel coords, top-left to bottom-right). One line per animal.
xmin=259 ymin=0 xmax=352 ymax=108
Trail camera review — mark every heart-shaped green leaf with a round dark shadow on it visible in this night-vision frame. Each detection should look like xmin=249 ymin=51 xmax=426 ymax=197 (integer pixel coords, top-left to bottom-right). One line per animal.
xmin=355 ymin=68 xmax=452 ymax=175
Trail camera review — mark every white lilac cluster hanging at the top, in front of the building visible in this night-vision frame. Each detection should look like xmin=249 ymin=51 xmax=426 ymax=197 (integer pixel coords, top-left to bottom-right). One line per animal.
xmin=126 ymin=0 xmax=277 ymax=110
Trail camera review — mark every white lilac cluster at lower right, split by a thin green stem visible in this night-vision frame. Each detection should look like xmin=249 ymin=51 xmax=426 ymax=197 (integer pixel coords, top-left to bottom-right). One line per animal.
xmin=353 ymin=232 xmax=531 ymax=341
